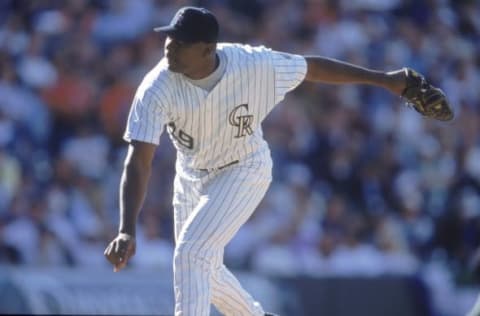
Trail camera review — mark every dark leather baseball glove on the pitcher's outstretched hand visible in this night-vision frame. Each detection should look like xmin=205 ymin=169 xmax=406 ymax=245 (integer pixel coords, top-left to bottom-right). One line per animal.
xmin=402 ymin=68 xmax=454 ymax=121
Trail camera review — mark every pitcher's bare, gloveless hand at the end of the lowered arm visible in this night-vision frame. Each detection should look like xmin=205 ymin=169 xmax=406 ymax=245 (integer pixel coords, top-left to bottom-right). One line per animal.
xmin=103 ymin=233 xmax=136 ymax=272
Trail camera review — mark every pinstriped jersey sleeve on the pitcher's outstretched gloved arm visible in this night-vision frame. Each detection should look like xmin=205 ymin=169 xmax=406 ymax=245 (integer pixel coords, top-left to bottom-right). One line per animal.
xmin=271 ymin=51 xmax=307 ymax=103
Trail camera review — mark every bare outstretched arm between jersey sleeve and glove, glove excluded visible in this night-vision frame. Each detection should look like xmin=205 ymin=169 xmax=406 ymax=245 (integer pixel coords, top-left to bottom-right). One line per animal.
xmin=305 ymin=56 xmax=405 ymax=95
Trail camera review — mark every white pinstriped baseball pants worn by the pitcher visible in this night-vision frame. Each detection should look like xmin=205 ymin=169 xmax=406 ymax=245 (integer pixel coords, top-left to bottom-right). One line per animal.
xmin=173 ymin=152 xmax=272 ymax=316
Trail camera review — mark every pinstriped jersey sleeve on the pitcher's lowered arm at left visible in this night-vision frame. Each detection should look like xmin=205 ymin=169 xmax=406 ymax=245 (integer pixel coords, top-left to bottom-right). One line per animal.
xmin=123 ymin=71 xmax=168 ymax=145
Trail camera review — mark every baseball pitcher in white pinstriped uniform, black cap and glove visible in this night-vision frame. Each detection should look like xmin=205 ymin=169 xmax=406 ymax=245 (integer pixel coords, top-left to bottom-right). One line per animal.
xmin=105 ymin=7 xmax=453 ymax=316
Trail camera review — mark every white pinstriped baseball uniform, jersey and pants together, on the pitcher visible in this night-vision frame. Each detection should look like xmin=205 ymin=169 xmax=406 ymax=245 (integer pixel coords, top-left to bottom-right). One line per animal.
xmin=124 ymin=44 xmax=306 ymax=316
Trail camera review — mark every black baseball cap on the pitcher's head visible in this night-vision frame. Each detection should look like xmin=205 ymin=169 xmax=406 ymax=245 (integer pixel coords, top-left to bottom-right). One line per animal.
xmin=153 ymin=7 xmax=218 ymax=43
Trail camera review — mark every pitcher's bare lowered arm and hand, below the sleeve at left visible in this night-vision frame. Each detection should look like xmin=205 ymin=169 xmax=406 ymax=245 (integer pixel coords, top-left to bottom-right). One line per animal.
xmin=104 ymin=141 xmax=155 ymax=271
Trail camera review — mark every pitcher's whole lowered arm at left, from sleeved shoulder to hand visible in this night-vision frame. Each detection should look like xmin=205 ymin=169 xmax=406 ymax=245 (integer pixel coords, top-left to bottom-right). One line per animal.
xmin=104 ymin=63 xmax=168 ymax=271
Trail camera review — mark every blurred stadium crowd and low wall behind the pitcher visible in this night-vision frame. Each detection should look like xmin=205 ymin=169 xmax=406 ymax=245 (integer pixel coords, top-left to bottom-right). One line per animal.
xmin=0 ymin=0 xmax=480 ymax=316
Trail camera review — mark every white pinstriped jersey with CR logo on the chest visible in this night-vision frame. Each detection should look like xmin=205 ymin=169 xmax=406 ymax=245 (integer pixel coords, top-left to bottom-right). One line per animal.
xmin=124 ymin=43 xmax=307 ymax=169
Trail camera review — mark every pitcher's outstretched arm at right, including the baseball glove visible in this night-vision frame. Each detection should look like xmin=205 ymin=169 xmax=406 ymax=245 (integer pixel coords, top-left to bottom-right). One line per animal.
xmin=305 ymin=56 xmax=454 ymax=121
